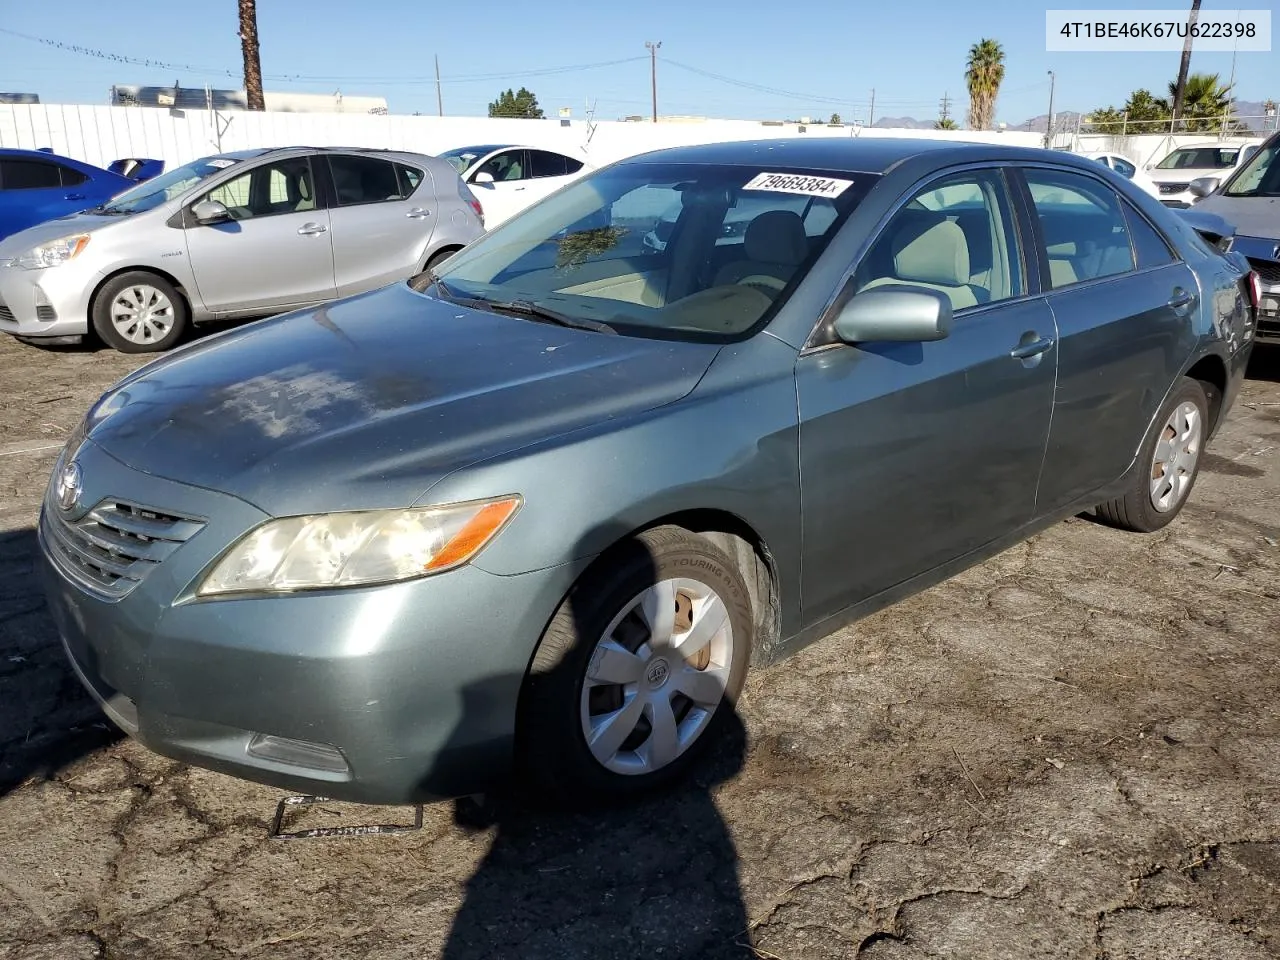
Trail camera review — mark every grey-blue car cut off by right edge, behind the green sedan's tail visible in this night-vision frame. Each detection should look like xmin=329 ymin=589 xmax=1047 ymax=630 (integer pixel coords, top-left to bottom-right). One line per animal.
xmin=1190 ymin=133 xmax=1280 ymax=343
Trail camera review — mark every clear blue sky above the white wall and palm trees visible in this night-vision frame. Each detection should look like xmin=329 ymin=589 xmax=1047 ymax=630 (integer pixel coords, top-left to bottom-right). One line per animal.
xmin=0 ymin=0 xmax=1280 ymax=127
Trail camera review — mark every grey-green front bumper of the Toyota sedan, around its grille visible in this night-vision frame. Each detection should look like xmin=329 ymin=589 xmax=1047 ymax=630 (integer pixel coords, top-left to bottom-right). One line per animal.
xmin=40 ymin=443 xmax=567 ymax=804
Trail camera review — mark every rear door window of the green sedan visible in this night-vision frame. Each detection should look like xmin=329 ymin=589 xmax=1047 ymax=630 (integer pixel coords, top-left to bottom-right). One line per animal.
xmin=1025 ymin=169 xmax=1134 ymax=288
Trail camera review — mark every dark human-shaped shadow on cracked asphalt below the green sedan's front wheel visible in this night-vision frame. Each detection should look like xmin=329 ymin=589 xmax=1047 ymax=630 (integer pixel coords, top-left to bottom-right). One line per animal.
xmin=442 ymin=529 xmax=756 ymax=960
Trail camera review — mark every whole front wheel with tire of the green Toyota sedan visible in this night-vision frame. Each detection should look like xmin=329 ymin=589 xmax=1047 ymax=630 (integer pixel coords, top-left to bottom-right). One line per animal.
xmin=520 ymin=527 xmax=755 ymax=803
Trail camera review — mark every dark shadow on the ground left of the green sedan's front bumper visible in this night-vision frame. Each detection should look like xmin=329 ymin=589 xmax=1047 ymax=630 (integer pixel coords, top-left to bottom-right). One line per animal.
xmin=0 ymin=529 xmax=123 ymax=796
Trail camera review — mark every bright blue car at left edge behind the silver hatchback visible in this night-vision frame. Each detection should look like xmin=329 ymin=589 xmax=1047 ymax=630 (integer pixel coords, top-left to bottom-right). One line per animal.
xmin=0 ymin=148 xmax=134 ymax=241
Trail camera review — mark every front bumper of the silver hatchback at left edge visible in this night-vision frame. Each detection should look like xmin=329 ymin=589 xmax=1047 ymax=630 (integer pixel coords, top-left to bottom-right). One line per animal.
xmin=0 ymin=257 xmax=102 ymax=339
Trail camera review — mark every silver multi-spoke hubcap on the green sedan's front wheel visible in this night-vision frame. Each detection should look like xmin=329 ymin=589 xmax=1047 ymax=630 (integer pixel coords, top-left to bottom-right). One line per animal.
xmin=580 ymin=579 xmax=733 ymax=774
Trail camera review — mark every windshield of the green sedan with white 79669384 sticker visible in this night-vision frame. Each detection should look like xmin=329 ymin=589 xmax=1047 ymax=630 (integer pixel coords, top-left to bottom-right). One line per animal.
xmin=428 ymin=161 xmax=877 ymax=340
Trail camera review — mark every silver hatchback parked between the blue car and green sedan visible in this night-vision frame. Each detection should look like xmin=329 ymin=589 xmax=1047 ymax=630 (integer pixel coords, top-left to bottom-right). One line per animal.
xmin=0 ymin=147 xmax=484 ymax=353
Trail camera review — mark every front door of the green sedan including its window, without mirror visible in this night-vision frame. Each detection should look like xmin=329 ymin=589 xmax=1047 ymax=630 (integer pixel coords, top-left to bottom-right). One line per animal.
xmin=796 ymin=170 xmax=1057 ymax=623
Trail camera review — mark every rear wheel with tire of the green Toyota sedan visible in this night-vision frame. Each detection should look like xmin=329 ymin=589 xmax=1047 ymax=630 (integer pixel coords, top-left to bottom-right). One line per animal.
xmin=1096 ymin=378 xmax=1210 ymax=534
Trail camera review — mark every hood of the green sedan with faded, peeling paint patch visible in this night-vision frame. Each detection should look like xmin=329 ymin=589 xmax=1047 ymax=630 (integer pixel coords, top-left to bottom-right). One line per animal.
xmin=84 ymin=284 xmax=718 ymax=516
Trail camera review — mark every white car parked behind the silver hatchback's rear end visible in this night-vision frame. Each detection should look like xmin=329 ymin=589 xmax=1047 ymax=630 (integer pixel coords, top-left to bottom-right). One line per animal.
xmin=440 ymin=143 xmax=590 ymax=229
